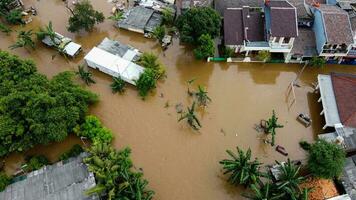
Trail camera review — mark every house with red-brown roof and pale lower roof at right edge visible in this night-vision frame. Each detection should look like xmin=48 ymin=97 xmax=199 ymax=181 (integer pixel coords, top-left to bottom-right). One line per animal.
xmin=317 ymin=73 xmax=356 ymax=152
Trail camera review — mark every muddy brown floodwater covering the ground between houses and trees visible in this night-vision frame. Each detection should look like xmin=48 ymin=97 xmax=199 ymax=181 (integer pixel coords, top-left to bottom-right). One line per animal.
xmin=0 ymin=0 xmax=356 ymax=200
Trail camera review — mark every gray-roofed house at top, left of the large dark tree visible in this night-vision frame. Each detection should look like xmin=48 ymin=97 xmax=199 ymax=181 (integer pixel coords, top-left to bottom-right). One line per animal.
xmin=116 ymin=6 xmax=162 ymax=34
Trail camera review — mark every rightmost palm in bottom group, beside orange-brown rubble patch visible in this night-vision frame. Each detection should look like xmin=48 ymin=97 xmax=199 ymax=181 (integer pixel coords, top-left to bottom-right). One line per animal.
xmin=276 ymin=159 xmax=305 ymax=200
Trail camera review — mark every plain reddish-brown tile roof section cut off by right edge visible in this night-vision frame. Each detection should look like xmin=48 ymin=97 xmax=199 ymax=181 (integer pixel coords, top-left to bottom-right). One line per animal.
xmin=331 ymin=73 xmax=356 ymax=127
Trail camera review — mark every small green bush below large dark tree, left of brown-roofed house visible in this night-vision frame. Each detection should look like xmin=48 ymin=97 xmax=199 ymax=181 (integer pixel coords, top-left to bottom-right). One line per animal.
xmin=194 ymin=34 xmax=215 ymax=59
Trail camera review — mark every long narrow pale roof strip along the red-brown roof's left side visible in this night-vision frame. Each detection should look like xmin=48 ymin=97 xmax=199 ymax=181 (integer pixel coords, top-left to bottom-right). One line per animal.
xmin=318 ymin=74 xmax=341 ymax=127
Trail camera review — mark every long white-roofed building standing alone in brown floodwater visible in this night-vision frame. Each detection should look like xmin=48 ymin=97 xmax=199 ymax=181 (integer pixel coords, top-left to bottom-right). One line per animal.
xmin=84 ymin=38 xmax=144 ymax=85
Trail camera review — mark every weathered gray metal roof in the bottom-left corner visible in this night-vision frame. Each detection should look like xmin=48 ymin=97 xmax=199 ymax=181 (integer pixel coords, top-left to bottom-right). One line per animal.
xmin=0 ymin=153 xmax=99 ymax=200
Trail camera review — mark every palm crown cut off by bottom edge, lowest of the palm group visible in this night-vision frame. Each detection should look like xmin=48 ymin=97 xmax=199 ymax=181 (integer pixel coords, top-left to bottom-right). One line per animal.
xmin=242 ymin=182 xmax=284 ymax=200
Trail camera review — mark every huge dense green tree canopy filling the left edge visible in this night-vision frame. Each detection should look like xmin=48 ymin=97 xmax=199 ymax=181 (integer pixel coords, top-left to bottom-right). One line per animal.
xmin=0 ymin=51 xmax=98 ymax=156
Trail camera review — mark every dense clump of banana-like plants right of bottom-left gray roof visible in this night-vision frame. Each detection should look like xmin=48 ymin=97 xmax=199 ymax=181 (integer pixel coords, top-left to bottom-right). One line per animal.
xmin=84 ymin=142 xmax=154 ymax=200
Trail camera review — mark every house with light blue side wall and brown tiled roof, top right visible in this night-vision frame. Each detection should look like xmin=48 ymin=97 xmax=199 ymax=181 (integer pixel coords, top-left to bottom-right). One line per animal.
xmin=312 ymin=4 xmax=354 ymax=63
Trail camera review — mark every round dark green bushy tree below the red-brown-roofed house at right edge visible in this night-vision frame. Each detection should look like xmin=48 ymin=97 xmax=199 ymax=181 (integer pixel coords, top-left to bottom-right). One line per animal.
xmin=308 ymin=140 xmax=345 ymax=179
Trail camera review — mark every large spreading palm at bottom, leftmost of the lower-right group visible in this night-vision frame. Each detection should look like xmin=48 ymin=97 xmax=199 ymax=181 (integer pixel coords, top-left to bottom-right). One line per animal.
xmin=220 ymin=147 xmax=266 ymax=187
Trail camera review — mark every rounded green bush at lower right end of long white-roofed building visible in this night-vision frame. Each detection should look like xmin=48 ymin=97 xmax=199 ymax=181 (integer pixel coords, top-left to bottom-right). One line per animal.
xmin=135 ymin=68 xmax=157 ymax=98
